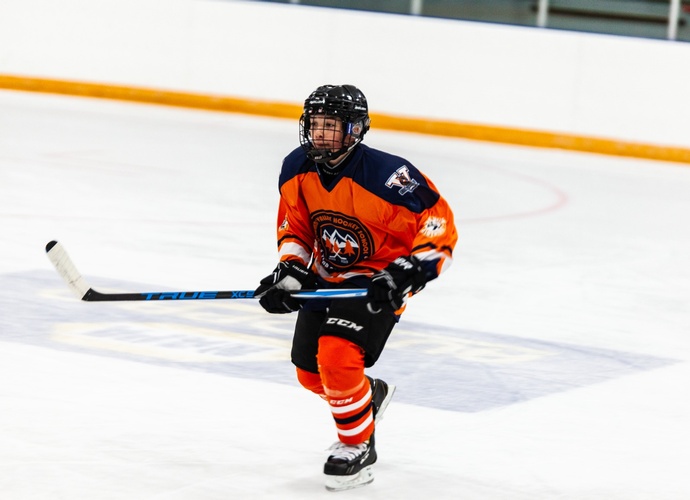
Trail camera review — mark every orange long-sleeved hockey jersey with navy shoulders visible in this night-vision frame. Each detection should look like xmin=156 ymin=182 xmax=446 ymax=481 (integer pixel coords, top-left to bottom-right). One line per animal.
xmin=278 ymin=144 xmax=457 ymax=286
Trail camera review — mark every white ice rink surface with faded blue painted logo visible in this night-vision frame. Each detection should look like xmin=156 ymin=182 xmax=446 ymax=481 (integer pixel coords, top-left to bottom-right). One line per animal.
xmin=0 ymin=92 xmax=690 ymax=500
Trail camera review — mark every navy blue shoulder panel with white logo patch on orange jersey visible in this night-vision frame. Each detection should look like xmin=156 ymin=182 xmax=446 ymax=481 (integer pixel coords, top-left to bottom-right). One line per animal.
xmin=345 ymin=144 xmax=439 ymax=213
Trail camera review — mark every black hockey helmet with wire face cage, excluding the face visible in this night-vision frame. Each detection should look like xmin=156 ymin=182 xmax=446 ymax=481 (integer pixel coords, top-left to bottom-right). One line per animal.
xmin=299 ymin=85 xmax=371 ymax=163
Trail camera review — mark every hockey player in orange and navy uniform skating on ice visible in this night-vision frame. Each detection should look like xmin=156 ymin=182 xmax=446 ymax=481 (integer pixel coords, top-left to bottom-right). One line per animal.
xmin=255 ymin=85 xmax=457 ymax=490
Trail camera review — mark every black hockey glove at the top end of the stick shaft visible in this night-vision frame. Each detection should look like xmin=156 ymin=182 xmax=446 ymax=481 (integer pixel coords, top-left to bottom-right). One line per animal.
xmin=367 ymin=256 xmax=428 ymax=314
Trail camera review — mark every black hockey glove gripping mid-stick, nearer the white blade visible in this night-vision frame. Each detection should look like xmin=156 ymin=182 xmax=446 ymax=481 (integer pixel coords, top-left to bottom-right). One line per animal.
xmin=254 ymin=261 xmax=316 ymax=314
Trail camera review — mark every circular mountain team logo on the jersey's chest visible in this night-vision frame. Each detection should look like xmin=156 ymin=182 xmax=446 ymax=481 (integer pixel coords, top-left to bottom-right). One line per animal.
xmin=311 ymin=210 xmax=374 ymax=270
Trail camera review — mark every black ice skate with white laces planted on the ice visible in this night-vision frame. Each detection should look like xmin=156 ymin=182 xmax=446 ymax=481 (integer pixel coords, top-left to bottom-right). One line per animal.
xmin=323 ymin=434 xmax=376 ymax=491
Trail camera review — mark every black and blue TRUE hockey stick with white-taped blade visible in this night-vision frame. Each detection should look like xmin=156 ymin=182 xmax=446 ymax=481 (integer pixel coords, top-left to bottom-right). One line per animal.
xmin=46 ymin=241 xmax=367 ymax=302
